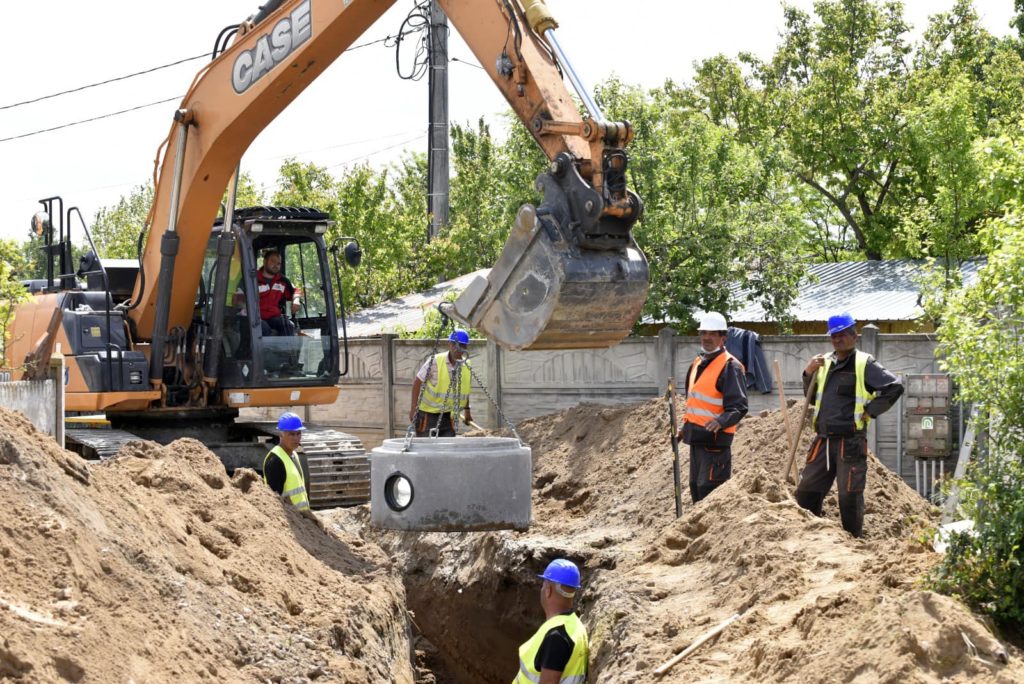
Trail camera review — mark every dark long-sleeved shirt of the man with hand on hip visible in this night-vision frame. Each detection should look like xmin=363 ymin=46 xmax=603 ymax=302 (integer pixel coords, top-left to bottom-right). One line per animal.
xmin=804 ymin=352 xmax=903 ymax=436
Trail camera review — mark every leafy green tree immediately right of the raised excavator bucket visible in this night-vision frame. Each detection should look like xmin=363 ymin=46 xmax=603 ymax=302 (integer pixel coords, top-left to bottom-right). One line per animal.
xmin=599 ymin=77 xmax=808 ymax=324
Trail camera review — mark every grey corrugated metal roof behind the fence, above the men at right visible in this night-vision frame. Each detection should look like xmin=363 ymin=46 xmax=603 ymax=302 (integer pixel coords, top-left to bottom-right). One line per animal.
xmin=729 ymin=259 xmax=984 ymax=323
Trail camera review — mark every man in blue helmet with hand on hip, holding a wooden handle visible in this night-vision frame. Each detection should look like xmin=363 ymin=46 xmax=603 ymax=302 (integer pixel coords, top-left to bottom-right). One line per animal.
xmin=796 ymin=312 xmax=903 ymax=537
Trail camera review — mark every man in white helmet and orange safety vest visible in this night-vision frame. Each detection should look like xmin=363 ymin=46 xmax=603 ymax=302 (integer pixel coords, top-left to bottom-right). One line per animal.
xmin=677 ymin=311 xmax=748 ymax=504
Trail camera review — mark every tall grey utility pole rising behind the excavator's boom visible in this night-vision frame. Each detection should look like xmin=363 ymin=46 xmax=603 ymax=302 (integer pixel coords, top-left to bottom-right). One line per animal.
xmin=427 ymin=0 xmax=449 ymax=242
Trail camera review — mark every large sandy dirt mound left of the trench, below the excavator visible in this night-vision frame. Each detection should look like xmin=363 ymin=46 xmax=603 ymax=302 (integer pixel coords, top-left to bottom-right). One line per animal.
xmin=0 ymin=410 xmax=414 ymax=683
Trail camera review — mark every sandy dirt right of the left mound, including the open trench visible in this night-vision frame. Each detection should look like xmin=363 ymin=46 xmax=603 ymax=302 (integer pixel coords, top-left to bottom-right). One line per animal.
xmin=326 ymin=400 xmax=1024 ymax=683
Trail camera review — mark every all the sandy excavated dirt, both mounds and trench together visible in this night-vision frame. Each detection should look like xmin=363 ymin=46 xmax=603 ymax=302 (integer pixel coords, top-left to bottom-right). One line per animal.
xmin=0 ymin=393 xmax=1024 ymax=684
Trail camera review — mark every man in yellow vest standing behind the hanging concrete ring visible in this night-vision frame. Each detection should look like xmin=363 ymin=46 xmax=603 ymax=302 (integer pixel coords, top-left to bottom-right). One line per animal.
xmin=409 ymin=330 xmax=473 ymax=437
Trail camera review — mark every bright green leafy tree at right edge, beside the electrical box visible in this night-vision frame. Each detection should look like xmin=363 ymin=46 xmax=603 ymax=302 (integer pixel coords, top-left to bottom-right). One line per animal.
xmin=929 ymin=202 xmax=1024 ymax=626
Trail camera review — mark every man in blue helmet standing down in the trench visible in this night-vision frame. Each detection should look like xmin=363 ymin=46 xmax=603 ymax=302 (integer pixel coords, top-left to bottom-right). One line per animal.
xmin=512 ymin=558 xmax=590 ymax=684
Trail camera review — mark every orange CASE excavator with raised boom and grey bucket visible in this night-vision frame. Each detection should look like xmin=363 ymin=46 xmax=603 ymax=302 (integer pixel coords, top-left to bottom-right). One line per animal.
xmin=6 ymin=0 xmax=648 ymax=507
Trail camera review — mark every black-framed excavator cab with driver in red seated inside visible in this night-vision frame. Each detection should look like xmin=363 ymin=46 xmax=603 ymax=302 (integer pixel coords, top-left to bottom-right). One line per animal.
xmin=199 ymin=207 xmax=340 ymax=398
